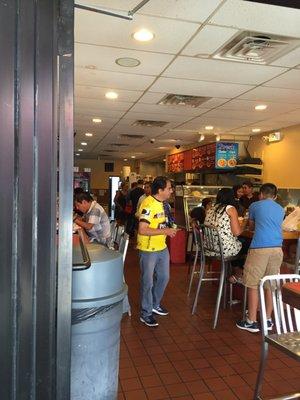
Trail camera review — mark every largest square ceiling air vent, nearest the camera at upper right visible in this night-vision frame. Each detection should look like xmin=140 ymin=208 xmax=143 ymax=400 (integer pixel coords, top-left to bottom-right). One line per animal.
xmin=213 ymin=32 xmax=300 ymax=64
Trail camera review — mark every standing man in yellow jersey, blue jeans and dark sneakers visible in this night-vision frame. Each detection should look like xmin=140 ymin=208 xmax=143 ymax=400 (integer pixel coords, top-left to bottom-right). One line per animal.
xmin=137 ymin=176 xmax=176 ymax=326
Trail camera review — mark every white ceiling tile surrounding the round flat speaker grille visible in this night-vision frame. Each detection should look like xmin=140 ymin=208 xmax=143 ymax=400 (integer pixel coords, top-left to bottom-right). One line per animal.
xmin=75 ymin=43 xmax=174 ymax=75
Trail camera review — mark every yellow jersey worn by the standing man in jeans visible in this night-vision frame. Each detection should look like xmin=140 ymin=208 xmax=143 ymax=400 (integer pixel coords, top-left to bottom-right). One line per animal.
xmin=137 ymin=196 xmax=167 ymax=251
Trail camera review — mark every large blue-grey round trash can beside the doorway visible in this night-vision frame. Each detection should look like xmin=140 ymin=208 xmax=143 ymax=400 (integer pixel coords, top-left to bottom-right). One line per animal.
xmin=71 ymin=244 xmax=127 ymax=400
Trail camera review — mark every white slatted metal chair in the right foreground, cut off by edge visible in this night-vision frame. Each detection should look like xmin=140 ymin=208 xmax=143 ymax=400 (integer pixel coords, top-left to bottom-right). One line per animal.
xmin=254 ymin=274 xmax=300 ymax=400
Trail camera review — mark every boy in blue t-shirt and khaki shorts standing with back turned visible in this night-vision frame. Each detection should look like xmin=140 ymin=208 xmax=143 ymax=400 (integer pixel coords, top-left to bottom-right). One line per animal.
xmin=236 ymin=183 xmax=284 ymax=332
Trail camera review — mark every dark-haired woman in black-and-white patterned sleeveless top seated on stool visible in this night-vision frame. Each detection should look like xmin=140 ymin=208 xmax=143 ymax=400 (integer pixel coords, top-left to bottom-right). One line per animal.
xmin=204 ymin=188 xmax=247 ymax=268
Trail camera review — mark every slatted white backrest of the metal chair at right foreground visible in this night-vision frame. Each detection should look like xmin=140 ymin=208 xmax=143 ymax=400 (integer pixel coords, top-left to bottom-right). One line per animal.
xmin=259 ymin=274 xmax=300 ymax=338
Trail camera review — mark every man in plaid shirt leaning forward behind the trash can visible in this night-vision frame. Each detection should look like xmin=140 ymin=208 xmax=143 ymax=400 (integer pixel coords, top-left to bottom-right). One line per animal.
xmin=74 ymin=193 xmax=111 ymax=245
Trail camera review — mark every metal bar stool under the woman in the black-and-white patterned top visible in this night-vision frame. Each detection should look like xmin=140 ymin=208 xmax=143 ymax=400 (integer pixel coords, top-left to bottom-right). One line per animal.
xmin=190 ymin=225 xmax=241 ymax=329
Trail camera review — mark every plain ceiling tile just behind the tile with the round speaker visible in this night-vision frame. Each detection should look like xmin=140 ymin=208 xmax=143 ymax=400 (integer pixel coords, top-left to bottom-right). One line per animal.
xmin=75 ymin=68 xmax=154 ymax=90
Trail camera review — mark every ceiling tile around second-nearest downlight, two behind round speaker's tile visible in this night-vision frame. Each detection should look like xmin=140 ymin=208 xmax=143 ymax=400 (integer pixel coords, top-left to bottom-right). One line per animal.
xmin=75 ymin=85 xmax=143 ymax=102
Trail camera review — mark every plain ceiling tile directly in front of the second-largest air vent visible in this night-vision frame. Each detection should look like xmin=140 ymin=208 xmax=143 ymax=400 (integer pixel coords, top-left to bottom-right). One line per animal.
xmin=151 ymin=77 xmax=253 ymax=98
